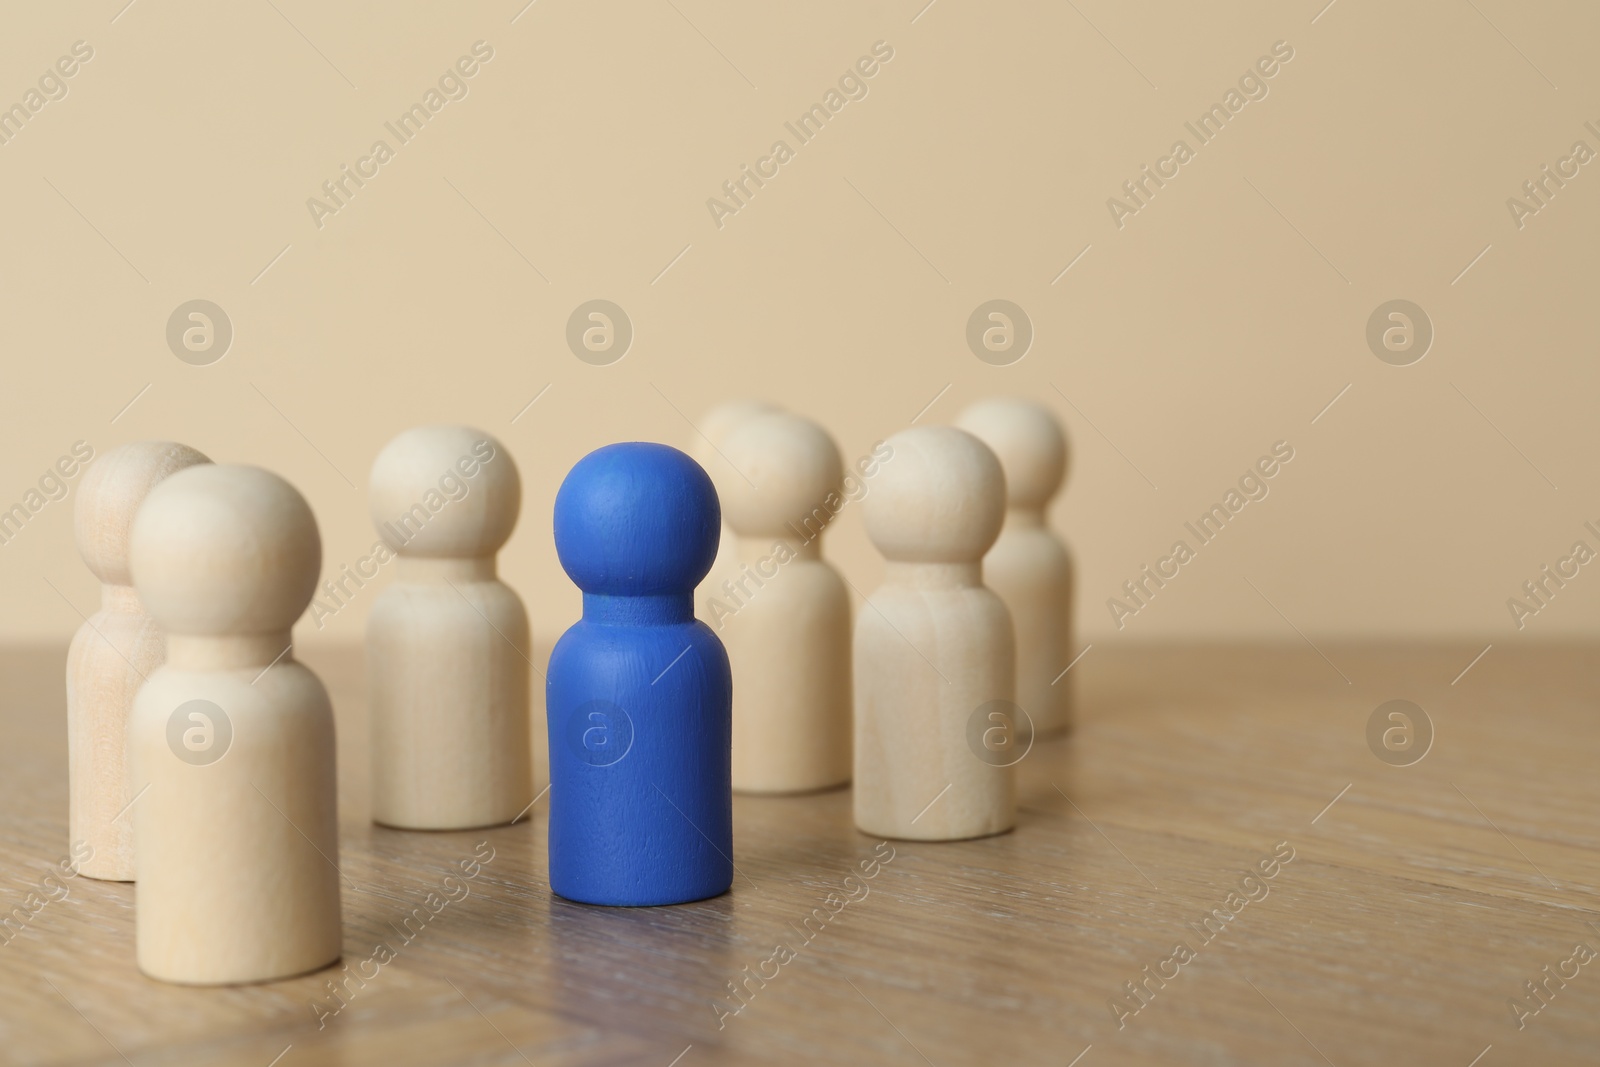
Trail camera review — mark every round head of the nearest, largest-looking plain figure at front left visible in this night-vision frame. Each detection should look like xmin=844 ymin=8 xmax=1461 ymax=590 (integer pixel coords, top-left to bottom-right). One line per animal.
xmin=130 ymin=464 xmax=322 ymax=637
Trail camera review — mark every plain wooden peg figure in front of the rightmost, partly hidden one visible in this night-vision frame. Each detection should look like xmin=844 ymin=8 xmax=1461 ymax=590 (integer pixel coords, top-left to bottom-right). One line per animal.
xmin=854 ymin=426 xmax=1016 ymax=841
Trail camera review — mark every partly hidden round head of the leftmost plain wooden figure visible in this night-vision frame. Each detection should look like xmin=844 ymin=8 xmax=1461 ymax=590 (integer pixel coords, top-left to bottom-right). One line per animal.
xmin=72 ymin=442 xmax=211 ymax=585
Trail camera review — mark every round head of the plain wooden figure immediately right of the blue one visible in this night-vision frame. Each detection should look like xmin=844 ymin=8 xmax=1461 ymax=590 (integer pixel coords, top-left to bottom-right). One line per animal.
xmin=712 ymin=411 xmax=845 ymax=537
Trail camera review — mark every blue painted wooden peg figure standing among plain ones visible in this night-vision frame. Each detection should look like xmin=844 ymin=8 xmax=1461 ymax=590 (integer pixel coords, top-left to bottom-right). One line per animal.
xmin=546 ymin=443 xmax=733 ymax=905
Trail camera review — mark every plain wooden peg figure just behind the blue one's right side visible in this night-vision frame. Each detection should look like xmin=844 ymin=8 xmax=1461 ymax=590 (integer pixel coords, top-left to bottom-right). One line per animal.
xmin=702 ymin=413 xmax=851 ymax=793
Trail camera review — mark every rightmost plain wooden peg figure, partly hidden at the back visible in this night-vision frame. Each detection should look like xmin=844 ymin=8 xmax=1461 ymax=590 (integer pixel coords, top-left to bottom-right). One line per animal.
xmin=955 ymin=398 xmax=1077 ymax=737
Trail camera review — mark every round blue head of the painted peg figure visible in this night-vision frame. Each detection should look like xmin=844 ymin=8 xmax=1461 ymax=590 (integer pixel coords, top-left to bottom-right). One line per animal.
xmin=555 ymin=442 xmax=722 ymax=597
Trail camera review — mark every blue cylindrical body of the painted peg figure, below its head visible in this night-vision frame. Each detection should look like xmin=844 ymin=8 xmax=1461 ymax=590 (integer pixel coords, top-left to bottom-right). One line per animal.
xmin=546 ymin=595 xmax=733 ymax=905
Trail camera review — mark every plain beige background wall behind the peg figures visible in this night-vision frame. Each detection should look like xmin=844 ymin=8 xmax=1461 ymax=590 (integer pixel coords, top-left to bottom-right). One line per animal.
xmin=0 ymin=0 xmax=1600 ymax=652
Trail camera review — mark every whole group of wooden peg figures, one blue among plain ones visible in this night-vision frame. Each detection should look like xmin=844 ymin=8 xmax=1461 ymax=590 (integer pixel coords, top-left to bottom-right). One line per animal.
xmin=67 ymin=400 xmax=1072 ymax=984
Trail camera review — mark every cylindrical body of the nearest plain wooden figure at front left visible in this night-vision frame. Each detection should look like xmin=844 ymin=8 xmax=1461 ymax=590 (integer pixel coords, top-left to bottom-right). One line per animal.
xmin=130 ymin=643 xmax=341 ymax=985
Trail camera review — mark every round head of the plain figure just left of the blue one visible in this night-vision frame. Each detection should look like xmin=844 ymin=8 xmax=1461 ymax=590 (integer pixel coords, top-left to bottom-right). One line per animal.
xmin=366 ymin=426 xmax=522 ymax=558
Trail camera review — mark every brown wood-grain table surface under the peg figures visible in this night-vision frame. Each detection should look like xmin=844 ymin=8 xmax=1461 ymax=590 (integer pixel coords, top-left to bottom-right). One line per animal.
xmin=0 ymin=645 xmax=1600 ymax=1067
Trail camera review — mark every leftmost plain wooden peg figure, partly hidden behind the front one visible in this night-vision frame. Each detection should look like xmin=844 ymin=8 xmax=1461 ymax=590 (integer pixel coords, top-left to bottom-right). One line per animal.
xmin=67 ymin=442 xmax=211 ymax=881
